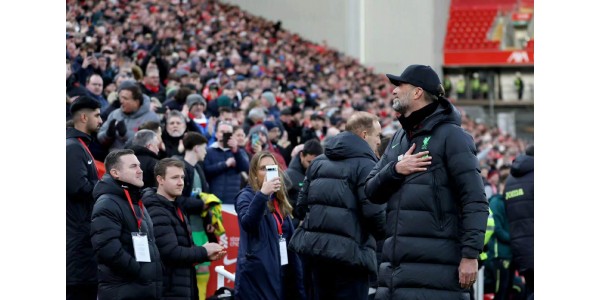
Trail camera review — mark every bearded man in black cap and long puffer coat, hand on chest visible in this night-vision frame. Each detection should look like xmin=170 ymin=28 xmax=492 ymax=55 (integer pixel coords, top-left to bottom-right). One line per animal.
xmin=365 ymin=65 xmax=489 ymax=299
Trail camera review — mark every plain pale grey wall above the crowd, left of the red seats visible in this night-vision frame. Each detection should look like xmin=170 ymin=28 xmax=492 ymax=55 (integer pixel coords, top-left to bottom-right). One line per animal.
xmin=222 ymin=0 xmax=450 ymax=75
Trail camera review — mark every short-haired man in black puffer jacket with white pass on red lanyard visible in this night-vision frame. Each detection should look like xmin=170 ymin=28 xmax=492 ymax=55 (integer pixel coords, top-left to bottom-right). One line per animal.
xmin=91 ymin=149 xmax=162 ymax=300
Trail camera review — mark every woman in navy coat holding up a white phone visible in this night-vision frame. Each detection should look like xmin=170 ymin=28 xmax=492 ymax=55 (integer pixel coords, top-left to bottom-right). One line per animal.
xmin=235 ymin=151 xmax=306 ymax=300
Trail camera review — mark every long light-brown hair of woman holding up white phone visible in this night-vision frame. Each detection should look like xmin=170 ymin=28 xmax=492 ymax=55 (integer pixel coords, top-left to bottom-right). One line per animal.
xmin=248 ymin=151 xmax=292 ymax=218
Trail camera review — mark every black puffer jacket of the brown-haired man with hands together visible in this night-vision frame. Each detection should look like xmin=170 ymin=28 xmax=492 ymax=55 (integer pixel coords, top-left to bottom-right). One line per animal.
xmin=142 ymin=188 xmax=208 ymax=299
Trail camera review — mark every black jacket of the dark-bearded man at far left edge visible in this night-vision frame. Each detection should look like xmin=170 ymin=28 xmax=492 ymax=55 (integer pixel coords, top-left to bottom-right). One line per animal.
xmin=66 ymin=128 xmax=98 ymax=285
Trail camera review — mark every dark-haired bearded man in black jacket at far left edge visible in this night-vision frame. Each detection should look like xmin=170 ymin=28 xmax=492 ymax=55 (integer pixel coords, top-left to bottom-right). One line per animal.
xmin=66 ymin=96 xmax=102 ymax=299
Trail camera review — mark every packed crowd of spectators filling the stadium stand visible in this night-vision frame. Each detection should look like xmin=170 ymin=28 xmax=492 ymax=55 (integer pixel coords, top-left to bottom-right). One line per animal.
xmin=66 ymin=0 xmax=527 ymax=300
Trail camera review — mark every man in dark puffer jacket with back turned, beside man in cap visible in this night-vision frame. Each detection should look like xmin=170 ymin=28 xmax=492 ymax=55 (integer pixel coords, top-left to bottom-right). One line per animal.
xmin=290 ymin=112 xmax=385 ymax=299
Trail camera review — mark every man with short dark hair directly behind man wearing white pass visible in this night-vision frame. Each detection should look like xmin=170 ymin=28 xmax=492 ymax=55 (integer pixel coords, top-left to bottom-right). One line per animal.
xmin=129 ymin=129 xmax=161 ymax=188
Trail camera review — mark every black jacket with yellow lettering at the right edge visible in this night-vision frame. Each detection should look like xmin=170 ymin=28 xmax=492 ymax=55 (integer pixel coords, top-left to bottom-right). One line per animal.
xmin=504 ymin=155 xmax=533 ymax=271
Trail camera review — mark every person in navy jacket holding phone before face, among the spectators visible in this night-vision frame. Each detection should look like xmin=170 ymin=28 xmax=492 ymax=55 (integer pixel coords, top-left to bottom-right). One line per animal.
xmin=204 ymin=123 xmax=248 ymax=204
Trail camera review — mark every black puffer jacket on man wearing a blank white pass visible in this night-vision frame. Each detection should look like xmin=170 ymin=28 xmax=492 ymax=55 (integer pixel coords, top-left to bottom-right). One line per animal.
xmin=91 ymin=174 xmax=162 ymax=300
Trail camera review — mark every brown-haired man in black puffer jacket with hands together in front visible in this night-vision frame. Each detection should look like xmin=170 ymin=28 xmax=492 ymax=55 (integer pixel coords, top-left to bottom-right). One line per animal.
xmin=142 ymin=158 xmax=225 ymax=299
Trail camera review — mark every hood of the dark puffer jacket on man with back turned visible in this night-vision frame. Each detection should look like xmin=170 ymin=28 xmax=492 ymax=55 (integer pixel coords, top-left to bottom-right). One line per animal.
xmin=324 ymin=131 xmax=377 ymax=160
